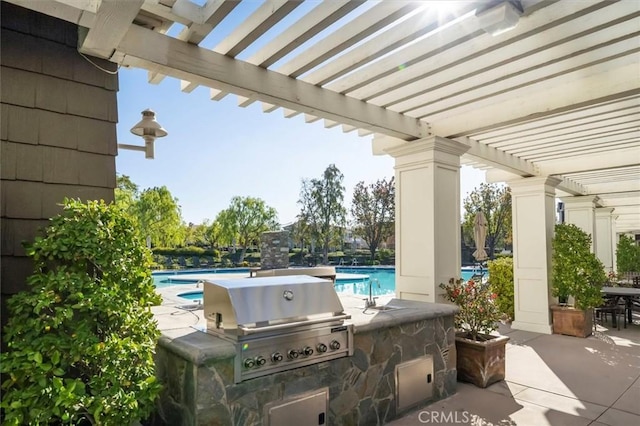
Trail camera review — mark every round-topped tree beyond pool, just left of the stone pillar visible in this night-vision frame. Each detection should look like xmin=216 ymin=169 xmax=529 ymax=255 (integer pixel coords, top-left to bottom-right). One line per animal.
xmin=216 ymin=197 xmax=279 ymax=263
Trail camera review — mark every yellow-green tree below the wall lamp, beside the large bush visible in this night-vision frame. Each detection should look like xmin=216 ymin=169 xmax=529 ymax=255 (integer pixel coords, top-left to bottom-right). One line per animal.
xmin=135 ymin=186 xmax=185 ymax=247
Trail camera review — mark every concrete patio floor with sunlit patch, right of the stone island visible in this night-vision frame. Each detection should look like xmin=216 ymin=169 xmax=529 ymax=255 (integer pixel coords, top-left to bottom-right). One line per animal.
xmin=389 ymin=312 xmax=640 ymax=426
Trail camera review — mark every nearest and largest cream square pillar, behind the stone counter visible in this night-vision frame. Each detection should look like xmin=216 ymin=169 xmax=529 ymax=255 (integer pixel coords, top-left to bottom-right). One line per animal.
xmin=386 ymin=136 xmax=469 ymax=303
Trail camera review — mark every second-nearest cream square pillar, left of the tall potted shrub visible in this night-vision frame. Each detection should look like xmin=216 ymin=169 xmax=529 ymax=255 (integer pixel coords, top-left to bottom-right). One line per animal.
xmin=508 ymin=177 xmax=560 ymax=334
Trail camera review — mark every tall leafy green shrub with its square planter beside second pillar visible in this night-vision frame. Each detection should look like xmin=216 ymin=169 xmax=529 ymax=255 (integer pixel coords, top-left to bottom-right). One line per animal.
xmin=551 ymin=223 xmax=607 ymax=337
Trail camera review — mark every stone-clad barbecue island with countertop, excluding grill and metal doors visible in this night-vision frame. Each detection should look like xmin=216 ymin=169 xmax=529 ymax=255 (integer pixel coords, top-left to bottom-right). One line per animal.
xmin=155 ymin=300 xmax=456 ymax=426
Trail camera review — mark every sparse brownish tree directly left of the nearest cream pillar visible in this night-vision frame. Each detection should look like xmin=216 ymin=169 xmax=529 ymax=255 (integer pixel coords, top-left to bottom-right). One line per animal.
xmin=351 ymin=177 xmax=396 ymax=261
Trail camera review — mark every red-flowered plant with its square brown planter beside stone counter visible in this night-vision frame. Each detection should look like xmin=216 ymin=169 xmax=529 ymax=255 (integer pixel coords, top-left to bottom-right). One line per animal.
xmin=440 ymin=278 xmax=509 ymax=388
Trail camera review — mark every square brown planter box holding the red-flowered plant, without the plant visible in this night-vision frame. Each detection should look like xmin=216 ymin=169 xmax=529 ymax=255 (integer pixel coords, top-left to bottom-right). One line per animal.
xmin=456 ymin=334 xmax=509 ymax=388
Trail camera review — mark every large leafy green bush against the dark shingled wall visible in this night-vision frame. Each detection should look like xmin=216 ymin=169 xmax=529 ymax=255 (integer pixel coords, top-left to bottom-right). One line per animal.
xmin=0 ymin=200 xmax=160 ymax=425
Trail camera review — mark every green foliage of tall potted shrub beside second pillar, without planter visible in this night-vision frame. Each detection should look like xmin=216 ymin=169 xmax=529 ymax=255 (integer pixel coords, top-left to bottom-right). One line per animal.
xmin=551 ymin=223 xmax=607 ymax=309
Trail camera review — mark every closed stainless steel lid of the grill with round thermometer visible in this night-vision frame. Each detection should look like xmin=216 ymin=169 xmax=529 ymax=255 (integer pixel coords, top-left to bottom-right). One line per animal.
xmin=203 ymin=275 xmax=344 ymax=330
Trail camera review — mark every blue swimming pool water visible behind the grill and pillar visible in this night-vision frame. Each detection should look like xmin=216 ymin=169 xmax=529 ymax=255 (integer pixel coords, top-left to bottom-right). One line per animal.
xmin=162 ymin=267 xmax=486 ymax=300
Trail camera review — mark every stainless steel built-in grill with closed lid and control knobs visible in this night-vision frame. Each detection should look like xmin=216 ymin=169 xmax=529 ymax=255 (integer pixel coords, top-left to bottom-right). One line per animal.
xmin=204 ymin=275 xmax=353 ymax=383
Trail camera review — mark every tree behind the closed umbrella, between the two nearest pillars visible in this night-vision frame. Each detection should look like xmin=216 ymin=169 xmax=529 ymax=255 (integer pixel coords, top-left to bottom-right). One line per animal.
xmin=462 ymin=183 xmax=511 ymax=259
